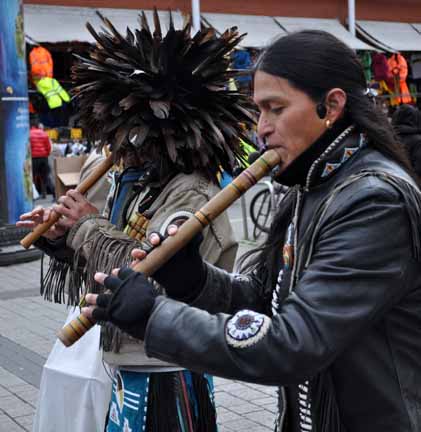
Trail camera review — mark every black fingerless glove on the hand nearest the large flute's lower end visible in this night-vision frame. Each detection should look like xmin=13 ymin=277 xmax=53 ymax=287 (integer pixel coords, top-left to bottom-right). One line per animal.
xmin=92 ymin=267 xmax=157 ymax=340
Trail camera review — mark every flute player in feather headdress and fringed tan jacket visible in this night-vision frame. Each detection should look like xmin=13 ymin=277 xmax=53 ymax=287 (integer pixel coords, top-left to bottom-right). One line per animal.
xmin=18 ymin=14 xmax=254 ymax=432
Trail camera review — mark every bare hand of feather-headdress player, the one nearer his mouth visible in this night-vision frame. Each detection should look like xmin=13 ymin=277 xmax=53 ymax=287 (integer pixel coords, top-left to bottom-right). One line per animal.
xmin=53 ymin=189 xmax=99 ymax=229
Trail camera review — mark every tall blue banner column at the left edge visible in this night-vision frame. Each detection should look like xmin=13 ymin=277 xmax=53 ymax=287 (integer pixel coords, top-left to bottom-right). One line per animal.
xmin=0 ymin=0 xmax=33 ymax=224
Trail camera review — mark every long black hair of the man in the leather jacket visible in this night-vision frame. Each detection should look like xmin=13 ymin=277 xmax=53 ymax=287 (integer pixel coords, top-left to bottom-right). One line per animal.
xmin=240 ymin=30 xmax=417 ymax=294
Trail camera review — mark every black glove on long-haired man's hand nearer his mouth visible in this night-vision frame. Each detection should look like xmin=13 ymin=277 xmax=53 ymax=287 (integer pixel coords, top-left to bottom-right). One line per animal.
xmin=152 ymin=233 xmax=206 ymax=303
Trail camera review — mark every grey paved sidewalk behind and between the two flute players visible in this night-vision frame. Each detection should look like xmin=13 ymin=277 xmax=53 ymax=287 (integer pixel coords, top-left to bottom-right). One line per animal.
xmin=0 ymin=205 xmax=276 ymax=432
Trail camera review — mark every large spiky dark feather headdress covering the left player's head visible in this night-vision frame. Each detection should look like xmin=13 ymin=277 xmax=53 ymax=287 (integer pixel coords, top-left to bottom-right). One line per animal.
xmin=72 ymin=10 xmax=256 ymax=180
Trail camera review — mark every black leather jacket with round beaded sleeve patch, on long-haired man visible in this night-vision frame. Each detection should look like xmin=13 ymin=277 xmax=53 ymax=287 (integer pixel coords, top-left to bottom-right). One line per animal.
xmin=145 ymin=129 xmax=421 ymax=432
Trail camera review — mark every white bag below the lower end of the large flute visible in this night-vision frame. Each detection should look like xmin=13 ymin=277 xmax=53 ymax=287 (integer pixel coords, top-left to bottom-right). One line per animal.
xmin=32 ymin=308 xmax=112 ymax=432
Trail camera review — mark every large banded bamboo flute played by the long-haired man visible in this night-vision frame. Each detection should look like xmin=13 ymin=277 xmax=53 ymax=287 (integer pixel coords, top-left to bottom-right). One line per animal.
xmin=57 ymin=150 xmax=281 ymax=346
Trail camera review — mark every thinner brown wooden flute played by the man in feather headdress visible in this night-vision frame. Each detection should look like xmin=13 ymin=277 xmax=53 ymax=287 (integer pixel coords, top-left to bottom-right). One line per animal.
xmin=20 ymin=154 xmax=114 ymax=249
